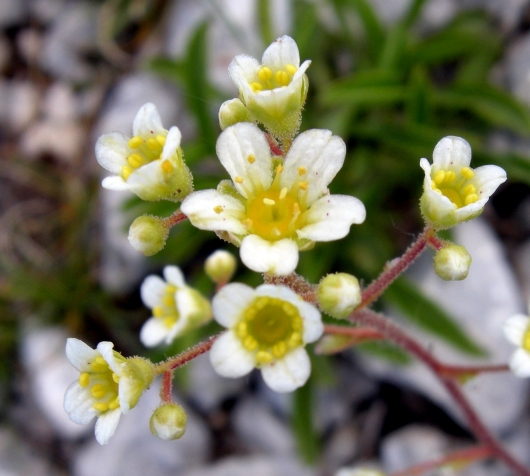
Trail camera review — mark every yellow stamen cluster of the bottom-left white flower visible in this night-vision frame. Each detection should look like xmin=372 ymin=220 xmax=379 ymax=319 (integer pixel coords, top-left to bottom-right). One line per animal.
xmin=79 ymin=356 xmax=121 ymax=413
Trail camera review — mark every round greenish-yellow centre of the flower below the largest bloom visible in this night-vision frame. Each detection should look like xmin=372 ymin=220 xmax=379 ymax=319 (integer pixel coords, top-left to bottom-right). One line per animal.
xmin=235 ymin=296 xmax=304 ymax=365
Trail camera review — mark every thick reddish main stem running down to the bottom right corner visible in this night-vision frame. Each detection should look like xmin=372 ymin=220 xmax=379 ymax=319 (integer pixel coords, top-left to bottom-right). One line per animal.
xmin=351 ymin=309 xmax=530 ymax=476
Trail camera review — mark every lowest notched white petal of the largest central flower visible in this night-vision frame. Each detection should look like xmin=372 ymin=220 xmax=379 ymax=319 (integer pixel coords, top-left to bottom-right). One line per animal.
xmin=239 ymin=235 xmax=298 ymax=276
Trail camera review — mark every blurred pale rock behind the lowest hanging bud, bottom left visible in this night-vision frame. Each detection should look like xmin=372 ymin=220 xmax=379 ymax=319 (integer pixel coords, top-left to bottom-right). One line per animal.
xmin=73 ymin=381 xmax=210 ymax=476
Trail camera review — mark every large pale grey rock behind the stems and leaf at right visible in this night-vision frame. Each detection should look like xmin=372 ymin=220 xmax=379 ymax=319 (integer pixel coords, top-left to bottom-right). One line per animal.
xmin=356 ymin=219 xmax=528 ymax=434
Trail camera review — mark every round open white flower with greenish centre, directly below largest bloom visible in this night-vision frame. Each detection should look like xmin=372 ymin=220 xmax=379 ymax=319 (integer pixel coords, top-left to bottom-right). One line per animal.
xmin=210 ymin=283 xmax=324 ymax=392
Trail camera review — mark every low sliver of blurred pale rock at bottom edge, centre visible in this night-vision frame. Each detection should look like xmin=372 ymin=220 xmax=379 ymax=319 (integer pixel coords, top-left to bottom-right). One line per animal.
xmin=180 ymin=455 xmax=317 ymax=476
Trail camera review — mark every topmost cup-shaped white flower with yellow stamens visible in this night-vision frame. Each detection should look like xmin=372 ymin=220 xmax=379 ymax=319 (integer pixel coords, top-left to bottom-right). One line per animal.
xmin=228 ymin=36 xmax=311 ymax=138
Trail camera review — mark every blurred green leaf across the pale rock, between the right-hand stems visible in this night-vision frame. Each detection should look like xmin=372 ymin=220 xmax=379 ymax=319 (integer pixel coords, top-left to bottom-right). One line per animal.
xmin=383 ymin=277 xmax=485 ymax=356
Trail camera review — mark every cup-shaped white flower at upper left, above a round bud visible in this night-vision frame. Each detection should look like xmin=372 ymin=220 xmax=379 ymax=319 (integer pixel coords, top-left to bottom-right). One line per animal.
xmin=96 ymin=103 xmax=193 ymax=201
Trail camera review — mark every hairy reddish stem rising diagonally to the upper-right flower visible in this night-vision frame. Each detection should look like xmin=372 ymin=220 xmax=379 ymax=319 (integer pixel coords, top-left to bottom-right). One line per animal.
xmin=358 ymin=228 xmax=434 ymax=309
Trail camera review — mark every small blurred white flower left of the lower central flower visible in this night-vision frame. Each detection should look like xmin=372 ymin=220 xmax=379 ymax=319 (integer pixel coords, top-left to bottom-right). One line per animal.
xmin=140 ymin=266 xmax=212 ymax=347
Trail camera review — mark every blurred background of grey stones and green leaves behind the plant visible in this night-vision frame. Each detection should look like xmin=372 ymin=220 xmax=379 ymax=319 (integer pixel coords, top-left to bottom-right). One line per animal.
xmin=0 ymin=0 xmax=530 ymax=476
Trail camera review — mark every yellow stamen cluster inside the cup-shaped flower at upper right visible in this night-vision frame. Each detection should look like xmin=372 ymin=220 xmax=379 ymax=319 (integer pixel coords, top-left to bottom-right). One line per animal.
xmin=431 ymin=167 xmax=478 ymax=208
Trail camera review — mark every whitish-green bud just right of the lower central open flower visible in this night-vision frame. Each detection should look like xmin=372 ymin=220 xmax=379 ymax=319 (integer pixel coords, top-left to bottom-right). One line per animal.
xmin=317 ymin=273 xmax=361 ymax=319
